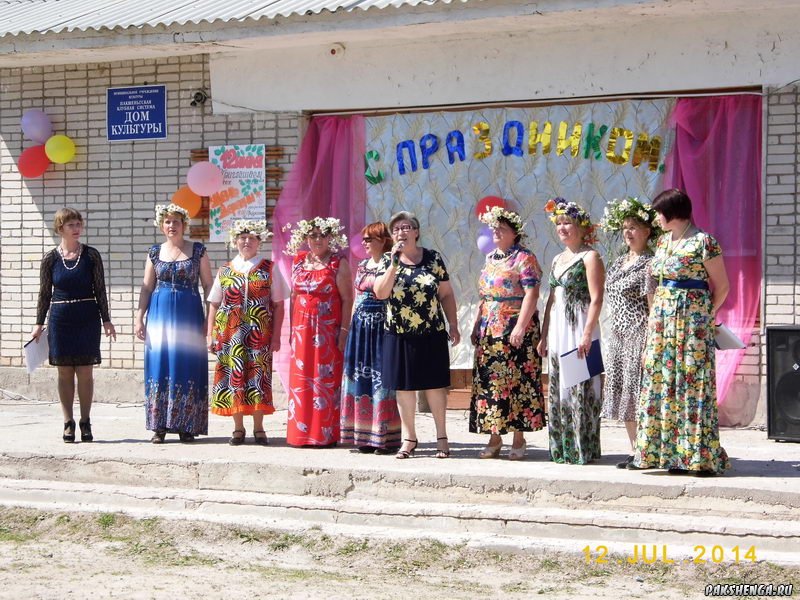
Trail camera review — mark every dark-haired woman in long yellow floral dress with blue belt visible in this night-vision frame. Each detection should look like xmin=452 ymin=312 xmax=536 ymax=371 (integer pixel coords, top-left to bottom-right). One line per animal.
xmin=628 ymin=190 xmax=729 ymax=476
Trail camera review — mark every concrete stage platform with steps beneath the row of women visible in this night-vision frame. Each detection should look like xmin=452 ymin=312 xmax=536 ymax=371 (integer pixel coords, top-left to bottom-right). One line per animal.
xmin=0 ymin=401 xmax=800 ymax=564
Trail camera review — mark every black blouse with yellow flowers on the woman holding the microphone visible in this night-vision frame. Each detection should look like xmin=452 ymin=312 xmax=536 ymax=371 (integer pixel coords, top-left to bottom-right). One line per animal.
xmin=378 ymin=248 xmax=450 ymax=335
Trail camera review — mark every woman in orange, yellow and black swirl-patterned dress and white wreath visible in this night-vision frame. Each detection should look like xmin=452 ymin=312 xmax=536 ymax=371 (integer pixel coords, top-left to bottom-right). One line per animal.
xmin=207 ymin=219 xmax=286 ymax=446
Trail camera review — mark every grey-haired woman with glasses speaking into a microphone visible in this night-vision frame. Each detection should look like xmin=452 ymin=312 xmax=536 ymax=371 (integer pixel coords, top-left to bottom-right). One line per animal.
xmin=373 ymin=212 xmax=461 ymax=458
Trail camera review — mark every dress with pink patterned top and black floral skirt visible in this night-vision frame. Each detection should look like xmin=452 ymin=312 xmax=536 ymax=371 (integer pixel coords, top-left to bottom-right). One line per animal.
xmin=469 ymin=246 xmax=545 ymax=435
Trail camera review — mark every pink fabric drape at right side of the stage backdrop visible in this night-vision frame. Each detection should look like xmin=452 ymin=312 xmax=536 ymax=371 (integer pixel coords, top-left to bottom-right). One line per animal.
xmin=665 ymin=95 xmax=761 ymax=425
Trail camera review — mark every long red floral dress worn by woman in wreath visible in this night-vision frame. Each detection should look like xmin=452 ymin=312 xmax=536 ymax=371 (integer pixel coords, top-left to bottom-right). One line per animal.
xmin=286 ymin=252 xmax=343 ymax=446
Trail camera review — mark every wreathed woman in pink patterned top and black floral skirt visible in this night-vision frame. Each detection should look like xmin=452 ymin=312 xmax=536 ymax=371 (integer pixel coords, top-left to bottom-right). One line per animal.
xmin=469 ymin=206 xmax=545 ymax=460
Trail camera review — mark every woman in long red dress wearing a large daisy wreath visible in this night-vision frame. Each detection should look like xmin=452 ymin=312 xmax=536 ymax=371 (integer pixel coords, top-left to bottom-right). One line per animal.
xmin=286 ymin=217 xmax=353 ymax=447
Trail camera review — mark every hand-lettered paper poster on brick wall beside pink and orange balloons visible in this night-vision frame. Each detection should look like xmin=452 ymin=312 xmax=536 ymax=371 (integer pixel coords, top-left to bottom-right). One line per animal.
xmin=208 ymin=144 xmax=267 ymax=242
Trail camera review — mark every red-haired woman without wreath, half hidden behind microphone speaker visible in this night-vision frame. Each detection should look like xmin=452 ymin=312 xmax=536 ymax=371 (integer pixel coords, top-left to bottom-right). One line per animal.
xmin=341 ymin=222 xmax=400 ymax=454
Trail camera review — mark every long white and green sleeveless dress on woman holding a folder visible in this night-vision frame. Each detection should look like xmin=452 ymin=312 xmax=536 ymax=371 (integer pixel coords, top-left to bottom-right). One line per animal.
xmin=547 ymin=254 xmax=602 ymax=464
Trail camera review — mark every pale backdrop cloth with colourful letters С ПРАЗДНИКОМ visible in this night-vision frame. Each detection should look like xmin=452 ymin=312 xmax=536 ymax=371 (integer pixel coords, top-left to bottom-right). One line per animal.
xmin=364 ymin=99 xmax=675 ymax=369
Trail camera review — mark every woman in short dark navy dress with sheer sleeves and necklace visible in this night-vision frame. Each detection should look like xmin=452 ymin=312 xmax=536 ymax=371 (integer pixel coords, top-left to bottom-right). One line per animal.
xmin=31 ymin=208 xmax=117 ymax=443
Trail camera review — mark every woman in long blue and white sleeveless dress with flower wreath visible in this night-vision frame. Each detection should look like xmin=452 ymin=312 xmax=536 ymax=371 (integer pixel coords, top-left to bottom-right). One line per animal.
xmin=135 ymin=204 xmax=212 ymax=444
